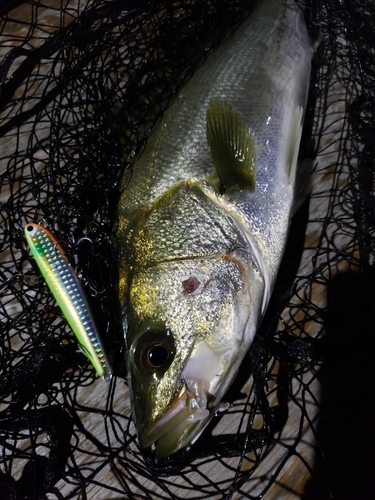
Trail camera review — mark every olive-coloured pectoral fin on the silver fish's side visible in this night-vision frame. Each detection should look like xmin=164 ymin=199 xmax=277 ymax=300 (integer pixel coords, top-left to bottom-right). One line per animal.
xmin=207 ymin=98 xmax=255 ymax=193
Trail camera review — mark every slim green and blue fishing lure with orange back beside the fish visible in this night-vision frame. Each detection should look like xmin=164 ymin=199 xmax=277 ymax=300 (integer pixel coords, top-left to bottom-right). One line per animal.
xmin=25 ymin=223 xmax=111 ymax=380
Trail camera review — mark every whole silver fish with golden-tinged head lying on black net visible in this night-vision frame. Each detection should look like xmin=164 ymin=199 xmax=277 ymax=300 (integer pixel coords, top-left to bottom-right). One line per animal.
xmin=117 ymin=0 xmax=313 ymax=459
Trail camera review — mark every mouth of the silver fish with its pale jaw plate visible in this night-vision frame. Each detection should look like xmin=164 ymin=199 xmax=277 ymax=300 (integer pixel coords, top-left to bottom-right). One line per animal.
xmin=142 ymin=342 xmax=221 ymax=458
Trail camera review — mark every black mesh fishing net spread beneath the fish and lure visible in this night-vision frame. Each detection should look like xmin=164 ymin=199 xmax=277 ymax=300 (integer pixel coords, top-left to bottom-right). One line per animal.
xmin=0 ymin=0 xmax=375 ymax=500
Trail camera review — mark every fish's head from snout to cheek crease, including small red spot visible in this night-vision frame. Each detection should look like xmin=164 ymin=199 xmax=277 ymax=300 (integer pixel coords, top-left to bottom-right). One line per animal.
xmin=126 ymin=254 xmax=255 ymax=458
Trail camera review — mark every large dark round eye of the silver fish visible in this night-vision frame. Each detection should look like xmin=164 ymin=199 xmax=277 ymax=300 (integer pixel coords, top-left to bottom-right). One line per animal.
xmin=132 ymin=328 xmax=174 ymax=373
